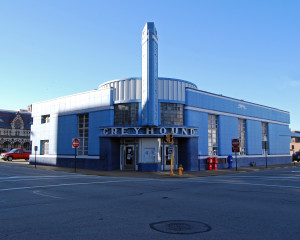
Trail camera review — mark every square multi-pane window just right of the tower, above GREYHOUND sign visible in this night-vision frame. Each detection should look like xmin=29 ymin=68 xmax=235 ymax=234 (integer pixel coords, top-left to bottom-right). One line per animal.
xmin=160 ymin=103 xmax=184 ymax=126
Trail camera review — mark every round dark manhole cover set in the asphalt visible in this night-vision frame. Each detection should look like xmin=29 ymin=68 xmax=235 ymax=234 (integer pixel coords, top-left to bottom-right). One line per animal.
xmin=150 ymin=220 xmax=211 ymax=234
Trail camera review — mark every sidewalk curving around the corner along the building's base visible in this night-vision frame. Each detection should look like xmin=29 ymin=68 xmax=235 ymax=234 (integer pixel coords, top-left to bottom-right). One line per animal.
xmin=4 ymin=160 xmax=300 ymax=178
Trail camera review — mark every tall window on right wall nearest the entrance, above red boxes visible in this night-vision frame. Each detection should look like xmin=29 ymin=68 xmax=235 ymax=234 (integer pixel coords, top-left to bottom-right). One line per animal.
xmin=208 ymin=114 xmax=218 ymax=155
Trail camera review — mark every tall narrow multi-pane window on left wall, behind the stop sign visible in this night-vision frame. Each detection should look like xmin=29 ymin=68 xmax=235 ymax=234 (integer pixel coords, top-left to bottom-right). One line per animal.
xmin=78 ymin=113 xmax=89 ymax=155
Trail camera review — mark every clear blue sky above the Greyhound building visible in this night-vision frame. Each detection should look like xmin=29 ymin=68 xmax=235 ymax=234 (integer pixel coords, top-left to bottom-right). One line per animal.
xmin=0 ymin=0 xmax=300 ymax=130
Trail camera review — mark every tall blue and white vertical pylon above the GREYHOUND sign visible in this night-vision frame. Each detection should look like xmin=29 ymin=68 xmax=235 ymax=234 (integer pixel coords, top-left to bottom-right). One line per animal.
xmin=142 ymin=22 xmax=158 ymax=126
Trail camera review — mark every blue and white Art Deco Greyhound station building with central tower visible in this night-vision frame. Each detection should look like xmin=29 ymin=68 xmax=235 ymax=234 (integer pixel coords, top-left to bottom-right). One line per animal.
xmin=30 ymin=22 xmax=291 ymax=171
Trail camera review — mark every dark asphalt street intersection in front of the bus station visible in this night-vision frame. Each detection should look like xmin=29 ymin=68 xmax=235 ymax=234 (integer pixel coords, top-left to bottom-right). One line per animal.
xmin=0 ymin=162 xmax=300 ymax=240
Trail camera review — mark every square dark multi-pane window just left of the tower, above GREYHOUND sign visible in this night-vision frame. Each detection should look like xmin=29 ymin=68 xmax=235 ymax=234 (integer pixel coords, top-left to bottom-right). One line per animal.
xmin=114 ymin=103 xmax=139 ymax=125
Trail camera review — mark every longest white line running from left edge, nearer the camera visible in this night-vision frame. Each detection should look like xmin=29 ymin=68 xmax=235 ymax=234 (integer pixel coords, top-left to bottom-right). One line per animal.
xmin=0 ymin=179 xmax=152 ymax=192
